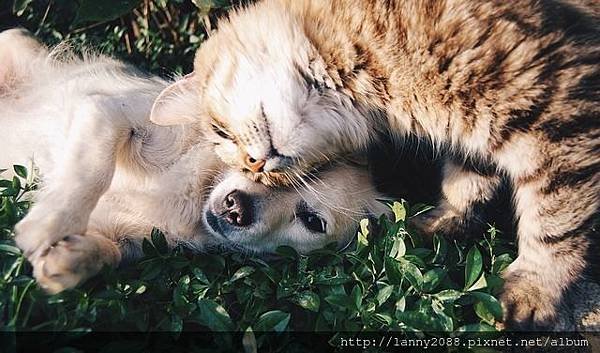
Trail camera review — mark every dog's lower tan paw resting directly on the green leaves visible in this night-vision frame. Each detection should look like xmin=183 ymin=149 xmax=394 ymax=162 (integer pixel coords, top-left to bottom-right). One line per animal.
xmin=33 ymin=234 xmax=120 ymax=293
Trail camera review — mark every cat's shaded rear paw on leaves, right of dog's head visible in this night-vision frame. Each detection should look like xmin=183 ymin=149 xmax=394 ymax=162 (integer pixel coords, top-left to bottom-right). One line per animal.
xmin=409 ymin=204 xmax=466 ymax=236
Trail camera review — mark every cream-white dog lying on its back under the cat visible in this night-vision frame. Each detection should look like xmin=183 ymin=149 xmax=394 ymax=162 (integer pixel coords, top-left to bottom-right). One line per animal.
xmin=0 ymin=30 xmax=385 ymax=292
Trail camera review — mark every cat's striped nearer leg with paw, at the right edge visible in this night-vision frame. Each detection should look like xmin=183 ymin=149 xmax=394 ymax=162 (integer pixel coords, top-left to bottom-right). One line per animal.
xmin=500 ymin=175 xmax=600 ymax=330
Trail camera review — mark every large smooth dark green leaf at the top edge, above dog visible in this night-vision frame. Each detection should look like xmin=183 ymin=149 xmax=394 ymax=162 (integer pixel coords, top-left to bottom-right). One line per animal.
xmin=74 ymin=0 xmax=141 ymax=24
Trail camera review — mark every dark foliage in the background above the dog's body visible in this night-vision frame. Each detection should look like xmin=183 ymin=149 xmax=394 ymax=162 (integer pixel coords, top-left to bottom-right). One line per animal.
xmin=0 ymin=0 xmax=247 ymax=76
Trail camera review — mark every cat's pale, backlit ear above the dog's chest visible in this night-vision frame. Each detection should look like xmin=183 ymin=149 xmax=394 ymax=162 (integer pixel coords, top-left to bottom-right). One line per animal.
xmin=150 ymin=73 xmax=200 ymax=126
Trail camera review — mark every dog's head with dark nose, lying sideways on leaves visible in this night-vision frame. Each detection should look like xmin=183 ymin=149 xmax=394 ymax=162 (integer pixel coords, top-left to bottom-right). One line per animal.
xmin=202 ymin=164 xmax=385 ymax=253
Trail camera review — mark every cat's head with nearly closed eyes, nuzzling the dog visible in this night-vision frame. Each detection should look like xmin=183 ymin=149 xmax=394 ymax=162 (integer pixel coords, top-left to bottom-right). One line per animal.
xmin=151 ymin=1 xmax=372 ymax=184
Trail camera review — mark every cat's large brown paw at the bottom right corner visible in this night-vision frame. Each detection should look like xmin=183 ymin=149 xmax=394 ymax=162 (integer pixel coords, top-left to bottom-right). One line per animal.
xmin=500 ymin=271 xmax=560 ymax=331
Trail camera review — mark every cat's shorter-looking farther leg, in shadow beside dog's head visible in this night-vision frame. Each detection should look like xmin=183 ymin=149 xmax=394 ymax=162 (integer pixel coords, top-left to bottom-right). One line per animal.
xmin=411 ymin=159 xmax=500 ymax=236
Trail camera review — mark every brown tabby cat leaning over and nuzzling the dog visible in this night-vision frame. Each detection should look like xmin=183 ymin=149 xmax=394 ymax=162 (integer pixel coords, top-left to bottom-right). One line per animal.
xmin=152 ymin=0 xmax=600 ymax=329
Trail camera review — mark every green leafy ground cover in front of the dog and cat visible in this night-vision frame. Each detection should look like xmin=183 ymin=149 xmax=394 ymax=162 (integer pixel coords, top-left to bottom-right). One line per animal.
xmin=0 ymin=166 xmax=513 ymax=346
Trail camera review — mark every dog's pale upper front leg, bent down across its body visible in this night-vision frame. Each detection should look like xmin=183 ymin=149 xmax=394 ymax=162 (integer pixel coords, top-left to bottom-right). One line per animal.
xmin=15 ymin=95 xmax=130 ymax=288
